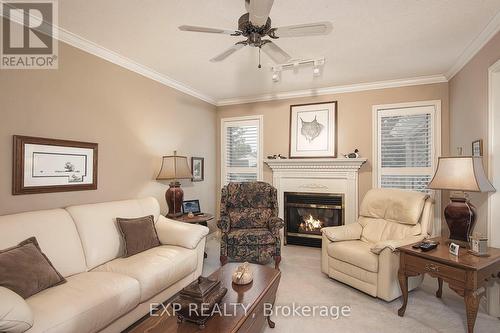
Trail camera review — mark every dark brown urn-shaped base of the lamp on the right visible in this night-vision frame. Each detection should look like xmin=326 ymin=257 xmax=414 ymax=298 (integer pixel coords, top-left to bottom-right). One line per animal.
xmin=444 ymin=197 xmax=477 ymax=247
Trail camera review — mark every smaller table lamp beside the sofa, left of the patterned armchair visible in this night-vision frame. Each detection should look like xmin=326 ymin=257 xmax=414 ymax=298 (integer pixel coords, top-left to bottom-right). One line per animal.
xmin=156 ymin=151 xmax=193 ymax=217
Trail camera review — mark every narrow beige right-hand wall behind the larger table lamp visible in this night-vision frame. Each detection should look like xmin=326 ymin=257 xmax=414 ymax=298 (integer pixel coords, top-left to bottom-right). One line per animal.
xmin=449 ymin=33 xmax=500 ymax=234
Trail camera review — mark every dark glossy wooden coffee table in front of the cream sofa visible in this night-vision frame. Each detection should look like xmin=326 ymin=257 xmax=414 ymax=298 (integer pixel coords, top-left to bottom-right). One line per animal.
xmin=129 ymin=263 xmax=281 ymax=333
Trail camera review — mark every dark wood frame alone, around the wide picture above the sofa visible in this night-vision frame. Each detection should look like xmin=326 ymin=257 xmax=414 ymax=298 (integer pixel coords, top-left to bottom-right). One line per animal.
xmin=12 ymin=135 xmax=98 ymax=195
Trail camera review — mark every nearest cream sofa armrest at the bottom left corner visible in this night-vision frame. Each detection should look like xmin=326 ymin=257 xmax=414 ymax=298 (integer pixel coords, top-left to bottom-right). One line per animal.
xmin=0 ymin=287 xmax=33 ymax=333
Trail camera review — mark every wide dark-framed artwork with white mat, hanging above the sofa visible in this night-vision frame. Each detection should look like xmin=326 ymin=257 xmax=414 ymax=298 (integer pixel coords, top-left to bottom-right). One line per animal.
xmin=12 ymin=135 xmax=98 ymax=195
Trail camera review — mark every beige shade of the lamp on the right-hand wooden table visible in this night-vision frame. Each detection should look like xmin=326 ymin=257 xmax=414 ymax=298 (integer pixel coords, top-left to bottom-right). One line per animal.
xmin=427 ymin=156 xmax=495 ymax=192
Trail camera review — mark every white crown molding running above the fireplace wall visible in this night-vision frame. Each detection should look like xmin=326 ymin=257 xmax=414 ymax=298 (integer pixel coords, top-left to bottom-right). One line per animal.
xmin=217 ymin=75 xmax=448 ymax=106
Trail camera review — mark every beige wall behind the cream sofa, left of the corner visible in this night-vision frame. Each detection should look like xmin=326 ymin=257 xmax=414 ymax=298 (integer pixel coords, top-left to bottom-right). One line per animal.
xmin=0 ymin=43 xmax=216 ymax=215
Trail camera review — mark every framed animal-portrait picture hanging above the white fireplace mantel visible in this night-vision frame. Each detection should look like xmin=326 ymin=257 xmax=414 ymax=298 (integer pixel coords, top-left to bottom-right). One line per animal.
xmin=288 ymin=101 xmax=337 ymax=158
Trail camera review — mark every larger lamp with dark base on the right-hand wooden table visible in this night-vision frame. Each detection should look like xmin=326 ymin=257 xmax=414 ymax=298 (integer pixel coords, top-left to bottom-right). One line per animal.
xmin=427 ymin=156 xmax=495 ymax=247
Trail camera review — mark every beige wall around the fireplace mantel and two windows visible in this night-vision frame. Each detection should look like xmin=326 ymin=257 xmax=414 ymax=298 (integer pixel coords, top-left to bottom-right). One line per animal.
xmin=217 ymin=83 xmax=449 ymax=214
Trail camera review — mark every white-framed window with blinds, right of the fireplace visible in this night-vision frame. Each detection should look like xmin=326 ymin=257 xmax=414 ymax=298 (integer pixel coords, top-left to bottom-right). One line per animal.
xmin=373 ymin=101 xmax=441 ymax=192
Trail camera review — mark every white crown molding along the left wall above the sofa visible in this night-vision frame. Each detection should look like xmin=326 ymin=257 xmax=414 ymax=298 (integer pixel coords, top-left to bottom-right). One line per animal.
xmin=54 ymin=27 xmax=217 ymax=106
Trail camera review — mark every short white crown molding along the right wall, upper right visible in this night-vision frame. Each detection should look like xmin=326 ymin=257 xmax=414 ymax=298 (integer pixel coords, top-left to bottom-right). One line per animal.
xmin=445 ymin=12 xmax=500 ymax=80
